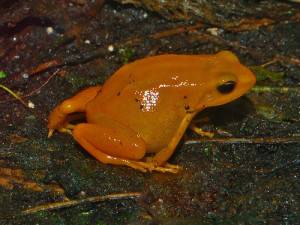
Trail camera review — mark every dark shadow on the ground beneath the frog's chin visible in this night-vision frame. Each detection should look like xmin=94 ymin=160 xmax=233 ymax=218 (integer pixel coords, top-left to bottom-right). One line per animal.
xmin=195 ymin=97 xmax=255 ymax=127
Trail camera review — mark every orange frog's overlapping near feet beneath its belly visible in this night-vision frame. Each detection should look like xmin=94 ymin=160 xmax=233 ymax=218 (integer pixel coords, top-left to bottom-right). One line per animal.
xmin=129 ymin=162 xmax=182 ymax=173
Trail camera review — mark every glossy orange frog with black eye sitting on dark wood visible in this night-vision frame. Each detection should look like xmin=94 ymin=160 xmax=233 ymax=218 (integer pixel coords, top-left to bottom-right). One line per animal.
xmin=48 ymin=51 xmax=256 ymax=173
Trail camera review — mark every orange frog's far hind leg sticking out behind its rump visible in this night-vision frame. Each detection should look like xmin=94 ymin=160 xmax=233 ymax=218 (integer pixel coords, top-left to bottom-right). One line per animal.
xmin=48 ymin=86 xmax=101 ymax=137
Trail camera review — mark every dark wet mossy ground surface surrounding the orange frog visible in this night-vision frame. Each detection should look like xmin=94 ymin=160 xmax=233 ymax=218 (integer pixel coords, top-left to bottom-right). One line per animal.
xmin=0 ymin=0 xmax=300 ymax=225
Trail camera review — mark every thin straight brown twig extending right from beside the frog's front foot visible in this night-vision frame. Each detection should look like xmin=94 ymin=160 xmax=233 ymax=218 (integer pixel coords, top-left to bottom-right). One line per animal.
xmin=184 ymin=134 xmax=300 ymax=145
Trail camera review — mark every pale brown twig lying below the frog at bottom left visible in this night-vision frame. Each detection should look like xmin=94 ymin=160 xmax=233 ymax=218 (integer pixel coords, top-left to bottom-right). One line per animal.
xmin=22 ymin=192 xmax=142 ymax=215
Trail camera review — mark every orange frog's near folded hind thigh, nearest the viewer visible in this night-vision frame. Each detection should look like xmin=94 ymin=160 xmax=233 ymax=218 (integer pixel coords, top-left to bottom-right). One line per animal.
xmin=73 ymin=123 xmax=146 ymax=163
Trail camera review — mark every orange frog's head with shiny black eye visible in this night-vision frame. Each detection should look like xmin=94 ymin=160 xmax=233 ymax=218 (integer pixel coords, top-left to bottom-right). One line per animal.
xmin=203 ymin=51 xmax=256 ymax=107
